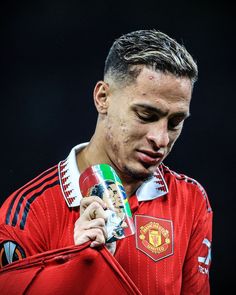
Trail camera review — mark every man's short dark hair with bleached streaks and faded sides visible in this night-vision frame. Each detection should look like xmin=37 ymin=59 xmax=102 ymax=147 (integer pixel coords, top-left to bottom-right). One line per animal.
xmin=104 ymin=30 xmax=198 ymax=85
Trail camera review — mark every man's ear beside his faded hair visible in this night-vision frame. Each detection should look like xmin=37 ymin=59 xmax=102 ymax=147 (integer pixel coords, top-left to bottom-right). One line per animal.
xmin=93 ymin=81 xmax=109 ymax=114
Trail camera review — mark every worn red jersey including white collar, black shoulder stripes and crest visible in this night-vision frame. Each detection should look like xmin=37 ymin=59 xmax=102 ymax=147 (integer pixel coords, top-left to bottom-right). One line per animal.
xmin=0 ymin=144 xmax=212 ymax=295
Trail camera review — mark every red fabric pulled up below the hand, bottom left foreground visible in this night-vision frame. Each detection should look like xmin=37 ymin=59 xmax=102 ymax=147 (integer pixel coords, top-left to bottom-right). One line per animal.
xmin=0 ymin=244 xmax=141 ymax=295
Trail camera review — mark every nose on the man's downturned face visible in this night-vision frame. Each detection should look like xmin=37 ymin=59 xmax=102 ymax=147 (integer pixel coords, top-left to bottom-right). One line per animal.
xmin=147 ymin=120 xmax=170 ymax=149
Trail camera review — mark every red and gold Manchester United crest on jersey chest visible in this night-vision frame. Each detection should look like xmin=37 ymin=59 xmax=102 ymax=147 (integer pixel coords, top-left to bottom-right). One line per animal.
xmin=135 ymin=215 xmax=173 ymax=261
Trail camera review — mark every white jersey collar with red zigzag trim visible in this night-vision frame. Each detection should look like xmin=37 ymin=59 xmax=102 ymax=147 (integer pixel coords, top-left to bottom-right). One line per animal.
xmin=58 ymin=142 xmax=168 ymax=207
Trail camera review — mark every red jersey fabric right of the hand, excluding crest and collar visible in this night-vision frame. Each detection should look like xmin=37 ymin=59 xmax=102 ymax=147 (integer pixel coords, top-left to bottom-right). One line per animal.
xmin=115 ymin=168 xmax=212 ymax=295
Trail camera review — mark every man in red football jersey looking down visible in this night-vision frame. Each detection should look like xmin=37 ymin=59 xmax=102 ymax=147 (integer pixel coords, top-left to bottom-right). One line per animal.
xmin=0 ymin=30 xmax=212 ymax=294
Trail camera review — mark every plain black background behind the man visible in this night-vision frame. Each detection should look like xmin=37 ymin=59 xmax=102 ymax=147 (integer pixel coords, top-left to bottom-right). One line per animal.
xmin=0 ymin=0 xmax=236 ymax=294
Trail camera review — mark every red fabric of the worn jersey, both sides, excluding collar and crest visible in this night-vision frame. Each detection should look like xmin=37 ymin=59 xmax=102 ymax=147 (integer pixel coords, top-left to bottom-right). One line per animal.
xmin=0 ymin=166 xmax=212 ymax=295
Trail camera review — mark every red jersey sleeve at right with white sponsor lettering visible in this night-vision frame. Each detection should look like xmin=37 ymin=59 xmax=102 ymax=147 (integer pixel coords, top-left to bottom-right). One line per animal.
xmin=181 ymin=185 xmax=213 ymax=295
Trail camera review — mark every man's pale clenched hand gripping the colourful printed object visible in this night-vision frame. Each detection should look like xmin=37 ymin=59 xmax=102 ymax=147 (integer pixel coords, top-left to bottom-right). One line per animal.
xmin=74 ymin=196 xmax=107 ymax=247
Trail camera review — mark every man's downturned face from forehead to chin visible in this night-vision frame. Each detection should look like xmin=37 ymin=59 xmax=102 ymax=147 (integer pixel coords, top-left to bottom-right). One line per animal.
xmin=99 ymin=68 xmax=192 ymax=180
